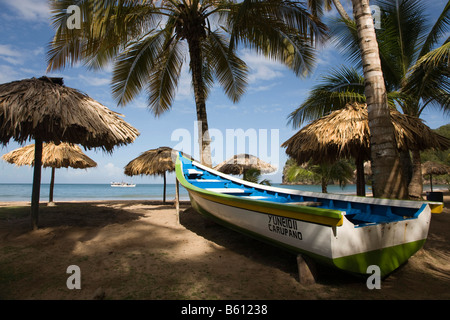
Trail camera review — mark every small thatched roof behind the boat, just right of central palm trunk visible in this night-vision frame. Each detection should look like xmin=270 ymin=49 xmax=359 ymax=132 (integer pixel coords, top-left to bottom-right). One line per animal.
xmin=214 ymin=153 xmax=277 ymax=174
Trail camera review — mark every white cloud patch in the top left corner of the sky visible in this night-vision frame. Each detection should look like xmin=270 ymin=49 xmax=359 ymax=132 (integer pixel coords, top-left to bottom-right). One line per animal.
xmin=0 ymin=0 xmax=50 ymax=22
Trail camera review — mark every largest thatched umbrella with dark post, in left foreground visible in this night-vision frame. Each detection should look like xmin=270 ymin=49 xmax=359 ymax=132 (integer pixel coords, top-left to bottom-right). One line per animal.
xmin=0 ymin=77 xmax=139 ymax=229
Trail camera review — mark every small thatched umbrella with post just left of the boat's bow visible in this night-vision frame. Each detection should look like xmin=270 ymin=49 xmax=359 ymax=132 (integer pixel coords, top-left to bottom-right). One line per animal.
xmin=125 ymin=147 xmax=189 ymax=203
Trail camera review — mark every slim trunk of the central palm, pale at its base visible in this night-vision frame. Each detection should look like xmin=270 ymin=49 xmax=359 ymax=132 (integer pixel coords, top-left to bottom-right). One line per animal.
xmin=188 ymin=37 xmax=212 ymax=167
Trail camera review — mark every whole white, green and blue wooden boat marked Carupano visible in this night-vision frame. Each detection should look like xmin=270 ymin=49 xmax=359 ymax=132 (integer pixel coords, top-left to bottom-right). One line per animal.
xmin=176 ymin=155 xmax=443 ymax=276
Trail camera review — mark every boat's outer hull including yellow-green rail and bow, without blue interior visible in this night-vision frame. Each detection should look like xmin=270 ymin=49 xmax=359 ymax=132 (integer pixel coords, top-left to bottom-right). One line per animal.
xmin=177 ymin=155 xmax=431 ymax=277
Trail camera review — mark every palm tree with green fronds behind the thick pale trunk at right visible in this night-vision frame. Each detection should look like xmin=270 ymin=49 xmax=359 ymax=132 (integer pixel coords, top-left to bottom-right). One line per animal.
xmin=290 ymin=0 xmax=450 ymax=197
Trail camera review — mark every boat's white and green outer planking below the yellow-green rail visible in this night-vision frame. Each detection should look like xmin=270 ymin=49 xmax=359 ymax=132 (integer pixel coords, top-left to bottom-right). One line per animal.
xmin=185 ymin=192 xmax=430 ymax=277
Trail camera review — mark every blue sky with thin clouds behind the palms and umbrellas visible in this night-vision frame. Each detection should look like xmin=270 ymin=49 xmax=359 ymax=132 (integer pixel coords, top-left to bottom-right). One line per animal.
xmin=0 ymin=0 xmax=449 ymax=184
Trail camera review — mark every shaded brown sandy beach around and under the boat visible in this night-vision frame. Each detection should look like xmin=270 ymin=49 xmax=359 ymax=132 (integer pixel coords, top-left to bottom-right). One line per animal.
xmin=0 ymin=193 xmax=450 ymax=300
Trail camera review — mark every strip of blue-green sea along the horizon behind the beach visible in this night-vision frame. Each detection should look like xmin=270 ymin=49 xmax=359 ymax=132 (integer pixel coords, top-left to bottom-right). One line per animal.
xmin=0 ymin=183 xmax=448 ymax=202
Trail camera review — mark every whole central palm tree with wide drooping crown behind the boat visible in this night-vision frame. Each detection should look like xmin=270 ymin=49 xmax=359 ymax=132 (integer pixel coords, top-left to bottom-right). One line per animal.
xmin=48 ymin=0 xmax=325 ymax=166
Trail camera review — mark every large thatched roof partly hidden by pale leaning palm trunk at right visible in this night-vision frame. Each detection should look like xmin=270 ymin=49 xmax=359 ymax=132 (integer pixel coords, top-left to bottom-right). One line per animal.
xmin=282 ymin=103 xmax=450 ymax=163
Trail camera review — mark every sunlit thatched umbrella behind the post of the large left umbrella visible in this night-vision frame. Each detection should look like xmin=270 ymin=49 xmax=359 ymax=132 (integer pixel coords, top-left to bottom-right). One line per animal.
xmin=2 ymin=142 xmax=97 ymax=204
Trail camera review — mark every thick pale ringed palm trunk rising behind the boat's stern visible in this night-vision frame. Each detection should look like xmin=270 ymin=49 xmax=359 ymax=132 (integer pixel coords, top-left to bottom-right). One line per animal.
xmin=352 ymin=0 xmax=408 ymax=199
